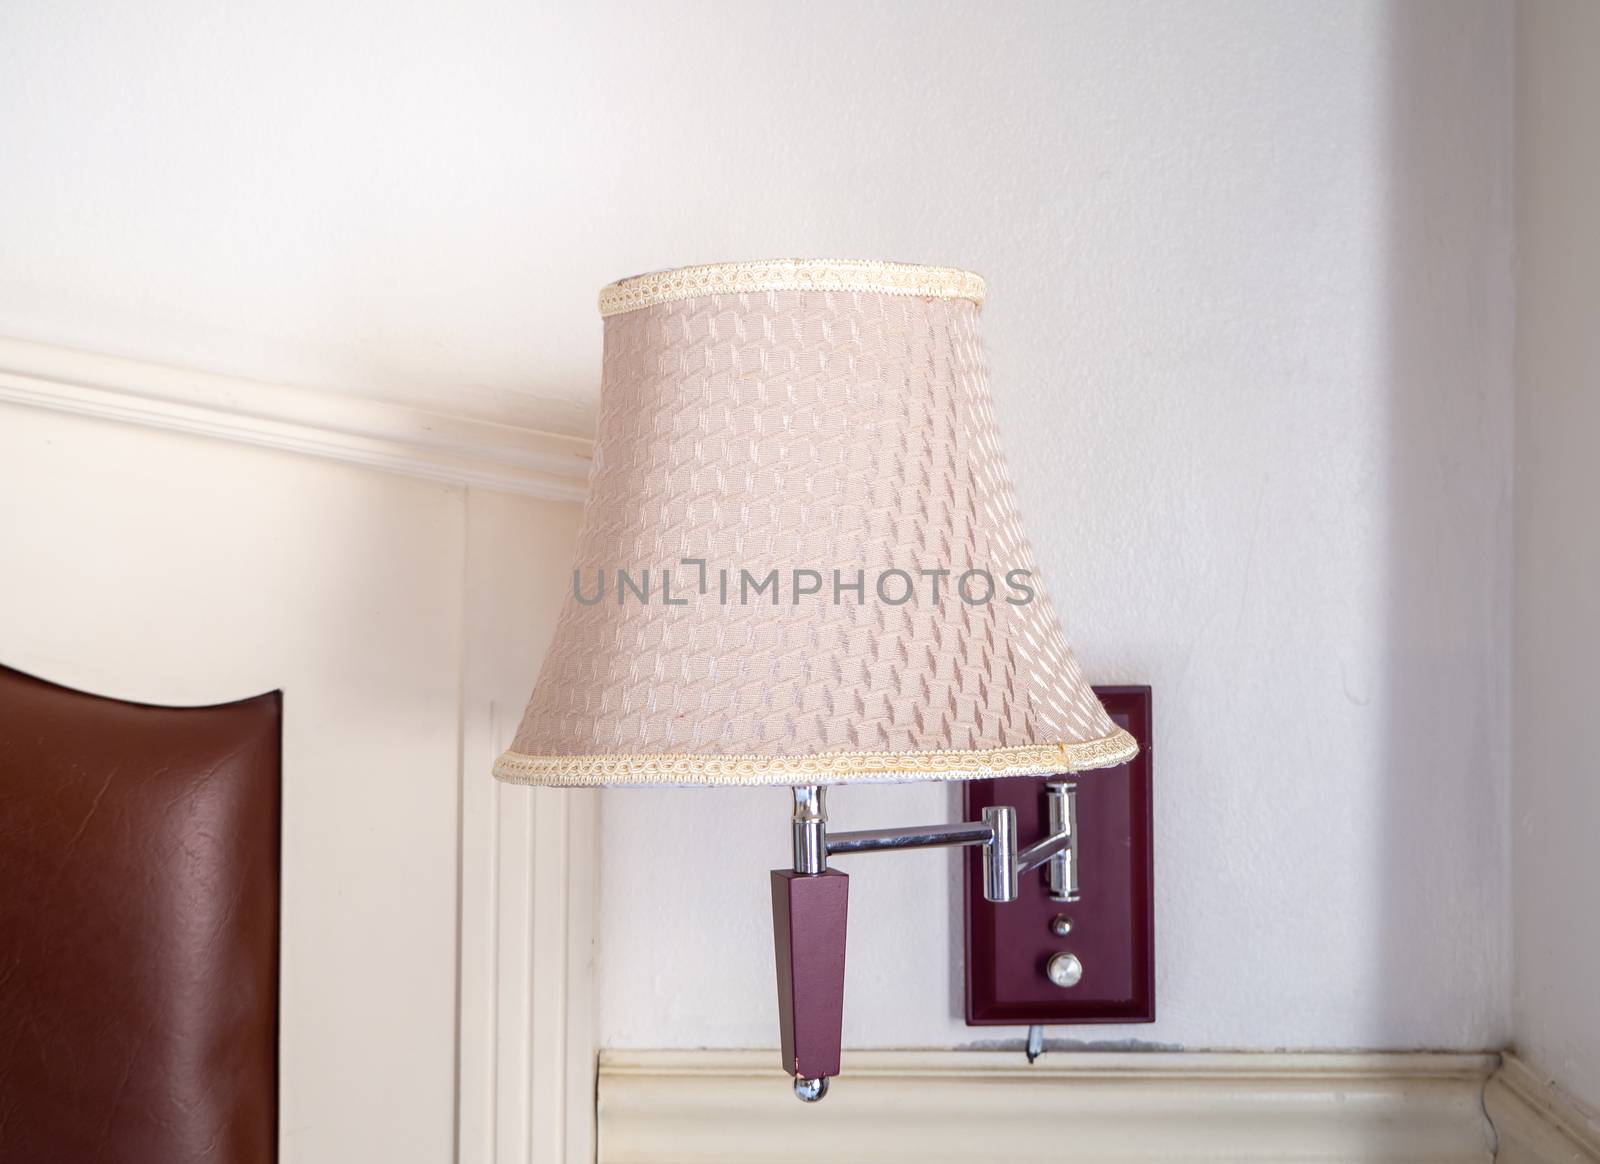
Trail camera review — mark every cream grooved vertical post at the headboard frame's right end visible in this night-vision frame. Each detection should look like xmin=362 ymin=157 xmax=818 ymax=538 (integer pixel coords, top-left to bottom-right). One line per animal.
xmin=459 ymin=491 xmax=600 ymax=1164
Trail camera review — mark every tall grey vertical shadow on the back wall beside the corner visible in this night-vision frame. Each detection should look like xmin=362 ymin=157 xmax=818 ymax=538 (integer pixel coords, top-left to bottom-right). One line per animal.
xmin=1376 ymin=0 xmax=1512 ymax=1049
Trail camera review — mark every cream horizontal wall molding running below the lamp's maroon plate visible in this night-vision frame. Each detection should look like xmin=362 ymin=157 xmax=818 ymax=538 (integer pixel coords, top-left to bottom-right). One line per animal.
xmin=598 ymin=1050 xmax=1498 ymax=1164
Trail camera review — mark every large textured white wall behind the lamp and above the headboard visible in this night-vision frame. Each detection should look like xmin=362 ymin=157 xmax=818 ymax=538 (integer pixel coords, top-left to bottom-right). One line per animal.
xmin=0 ymin=0 xmax=1510 ymax=1047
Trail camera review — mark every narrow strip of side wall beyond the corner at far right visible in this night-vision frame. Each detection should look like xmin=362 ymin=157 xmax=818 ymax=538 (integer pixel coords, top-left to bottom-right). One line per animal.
xmin=1512 ymin=0 xmax=1600 ymax=1106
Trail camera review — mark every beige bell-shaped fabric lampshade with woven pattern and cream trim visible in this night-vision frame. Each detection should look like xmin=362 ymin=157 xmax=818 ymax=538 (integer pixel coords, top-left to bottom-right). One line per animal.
xmin=494 ymin=261 xmax=1138 ymax=785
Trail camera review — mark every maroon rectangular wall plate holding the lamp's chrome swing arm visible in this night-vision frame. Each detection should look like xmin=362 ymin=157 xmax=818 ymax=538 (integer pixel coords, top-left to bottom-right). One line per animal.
xmin=965 ymin=688 xmax=1155 ymax=1026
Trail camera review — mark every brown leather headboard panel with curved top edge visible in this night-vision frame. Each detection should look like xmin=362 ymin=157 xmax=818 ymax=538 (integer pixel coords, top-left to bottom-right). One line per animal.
xmin=0 ymin=667 xmax=282 ymax=1164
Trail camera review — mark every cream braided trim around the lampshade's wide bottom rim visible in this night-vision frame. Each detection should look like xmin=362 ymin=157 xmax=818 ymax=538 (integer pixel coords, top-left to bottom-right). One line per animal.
xmin=494 ymin=728 xmax=1139 ymax=788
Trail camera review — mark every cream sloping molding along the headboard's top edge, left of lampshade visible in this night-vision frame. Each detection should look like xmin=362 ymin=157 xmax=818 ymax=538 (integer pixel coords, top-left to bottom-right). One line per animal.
xmin=0 ymin=337 xmax=592 ymax=500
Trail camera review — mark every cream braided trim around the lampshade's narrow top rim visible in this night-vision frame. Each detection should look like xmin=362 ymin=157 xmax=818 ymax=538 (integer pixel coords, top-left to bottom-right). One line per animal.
xmin=600 ymin=259 xmax=986 ymax=317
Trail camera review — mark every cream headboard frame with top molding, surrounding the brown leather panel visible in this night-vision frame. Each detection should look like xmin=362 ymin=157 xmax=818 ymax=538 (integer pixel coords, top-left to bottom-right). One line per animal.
xmin=0 ymin=356 xmax=597 ymax=1164
